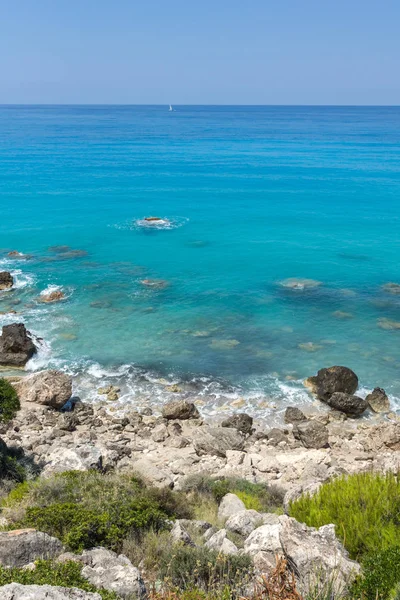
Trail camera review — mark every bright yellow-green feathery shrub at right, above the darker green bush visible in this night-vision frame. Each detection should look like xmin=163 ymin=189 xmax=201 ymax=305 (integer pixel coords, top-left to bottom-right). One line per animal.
xmin=289 ymin=473 xmax=400 ymax=560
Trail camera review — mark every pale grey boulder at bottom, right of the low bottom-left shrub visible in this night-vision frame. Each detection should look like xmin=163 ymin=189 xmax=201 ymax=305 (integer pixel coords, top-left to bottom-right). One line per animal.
xmin=81 ymin=548 xmax=146 ymax=600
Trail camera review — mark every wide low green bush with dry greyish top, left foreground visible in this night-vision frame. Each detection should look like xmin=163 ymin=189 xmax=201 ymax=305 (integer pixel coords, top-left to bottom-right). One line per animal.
xmin=3 ymin=471 xmax=187 ymax=551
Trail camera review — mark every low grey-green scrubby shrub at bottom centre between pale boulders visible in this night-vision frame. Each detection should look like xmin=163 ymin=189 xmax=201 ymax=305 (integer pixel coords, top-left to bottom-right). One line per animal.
xmin=159 ymin=545 xmax=253 ymax=595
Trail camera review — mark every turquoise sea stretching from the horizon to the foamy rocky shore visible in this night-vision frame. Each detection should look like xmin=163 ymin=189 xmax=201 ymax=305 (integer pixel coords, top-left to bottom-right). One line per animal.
xmin=0 ymin=106 xmax=400 ymax=414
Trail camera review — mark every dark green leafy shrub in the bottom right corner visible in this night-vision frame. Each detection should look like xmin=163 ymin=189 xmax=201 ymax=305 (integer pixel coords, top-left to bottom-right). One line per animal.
xmin=349 ymin=546 xmax=400 ymax=600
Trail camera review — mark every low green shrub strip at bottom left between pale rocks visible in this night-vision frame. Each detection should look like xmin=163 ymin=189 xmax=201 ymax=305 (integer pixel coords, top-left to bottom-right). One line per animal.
xmin=0 ymin=560 xmax=118 ymax=600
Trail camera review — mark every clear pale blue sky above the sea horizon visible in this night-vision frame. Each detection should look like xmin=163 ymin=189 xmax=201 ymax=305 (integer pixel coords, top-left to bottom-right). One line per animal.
xmin=0 ymin=0 xmax=400 ymax=104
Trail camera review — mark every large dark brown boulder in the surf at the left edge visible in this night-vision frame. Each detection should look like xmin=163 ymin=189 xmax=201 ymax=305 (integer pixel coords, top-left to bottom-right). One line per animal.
xmin=0 ymin=323 xmax=37 ymax=367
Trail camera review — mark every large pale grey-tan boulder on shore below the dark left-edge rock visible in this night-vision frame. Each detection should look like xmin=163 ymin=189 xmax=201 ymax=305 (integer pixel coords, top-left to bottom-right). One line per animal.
xmin=13 ymin=371 xmax=72 ymax=410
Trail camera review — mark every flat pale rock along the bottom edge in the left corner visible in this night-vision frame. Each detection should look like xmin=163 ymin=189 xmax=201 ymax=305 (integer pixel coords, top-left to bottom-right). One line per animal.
xmin=0 ymin=583 xmax=101 ymax=600
